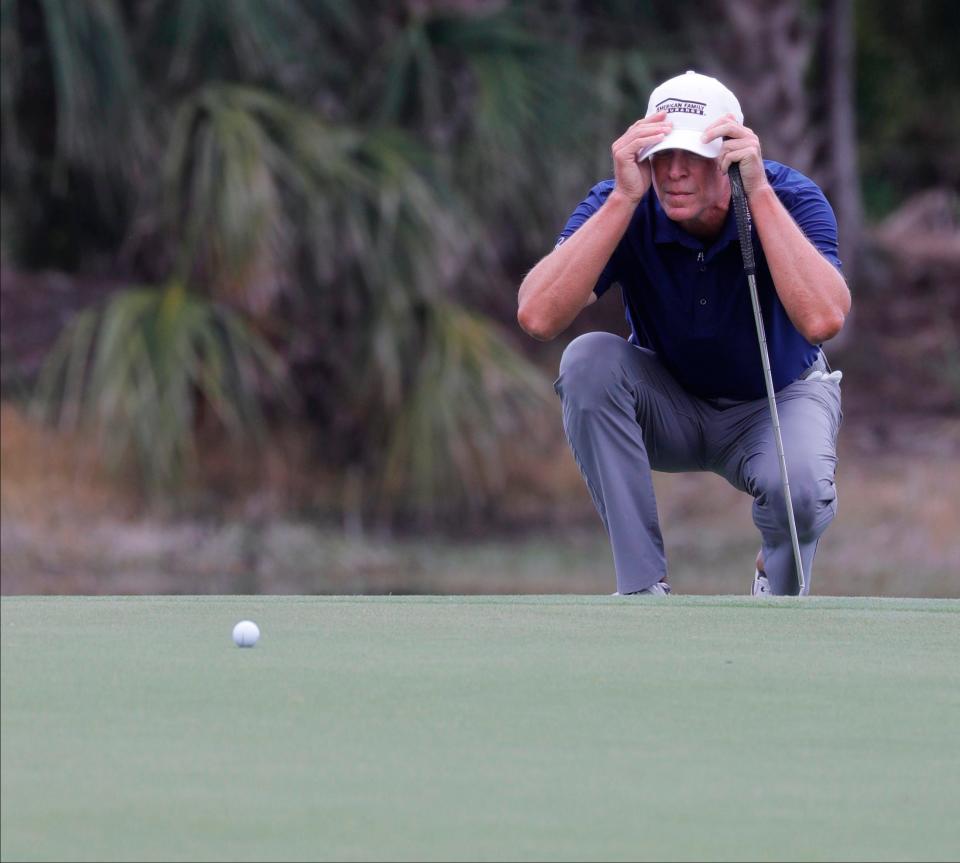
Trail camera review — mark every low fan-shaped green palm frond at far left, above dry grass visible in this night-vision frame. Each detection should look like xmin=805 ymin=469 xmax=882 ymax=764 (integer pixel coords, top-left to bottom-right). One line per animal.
xmin=35 ymin=283 xmax=289 ymax=493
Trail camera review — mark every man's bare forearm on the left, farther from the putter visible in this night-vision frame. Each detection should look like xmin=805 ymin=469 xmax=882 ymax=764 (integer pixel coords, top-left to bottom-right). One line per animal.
xmin=517 ymin=189 xmax=637 ymax=341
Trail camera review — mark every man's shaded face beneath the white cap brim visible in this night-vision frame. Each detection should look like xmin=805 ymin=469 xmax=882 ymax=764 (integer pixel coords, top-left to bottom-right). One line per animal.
xmin=650 ymin=150 xmax=730 ymax=234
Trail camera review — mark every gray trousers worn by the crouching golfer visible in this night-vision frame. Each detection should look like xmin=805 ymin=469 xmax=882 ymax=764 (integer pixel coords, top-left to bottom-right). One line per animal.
xmin=555 ymin=332 xmax=842 ymax=595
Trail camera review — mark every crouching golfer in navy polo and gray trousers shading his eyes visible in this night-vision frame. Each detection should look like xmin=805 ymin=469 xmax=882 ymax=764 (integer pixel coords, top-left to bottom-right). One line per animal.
xmin=517 ymin=72 xmax=850 ymax=595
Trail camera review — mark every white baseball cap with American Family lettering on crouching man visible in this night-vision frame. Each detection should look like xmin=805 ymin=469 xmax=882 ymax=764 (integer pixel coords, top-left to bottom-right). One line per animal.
xmin=640 ymin=71 xmax=743 ymax=159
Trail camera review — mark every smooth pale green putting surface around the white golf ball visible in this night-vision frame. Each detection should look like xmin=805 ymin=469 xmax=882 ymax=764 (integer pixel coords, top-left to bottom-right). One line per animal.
xmin=0 ymin=596 xmax=960 ymax=860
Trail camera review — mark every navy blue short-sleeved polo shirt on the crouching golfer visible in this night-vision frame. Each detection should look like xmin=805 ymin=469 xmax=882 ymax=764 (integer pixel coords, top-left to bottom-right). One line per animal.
xmin=557 ymin=160 xmax=840 ymax=399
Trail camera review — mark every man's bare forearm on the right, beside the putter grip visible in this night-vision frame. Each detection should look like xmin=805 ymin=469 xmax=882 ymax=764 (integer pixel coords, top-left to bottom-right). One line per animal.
xmin=750 ymin=186 xmax=850 ymax=344
